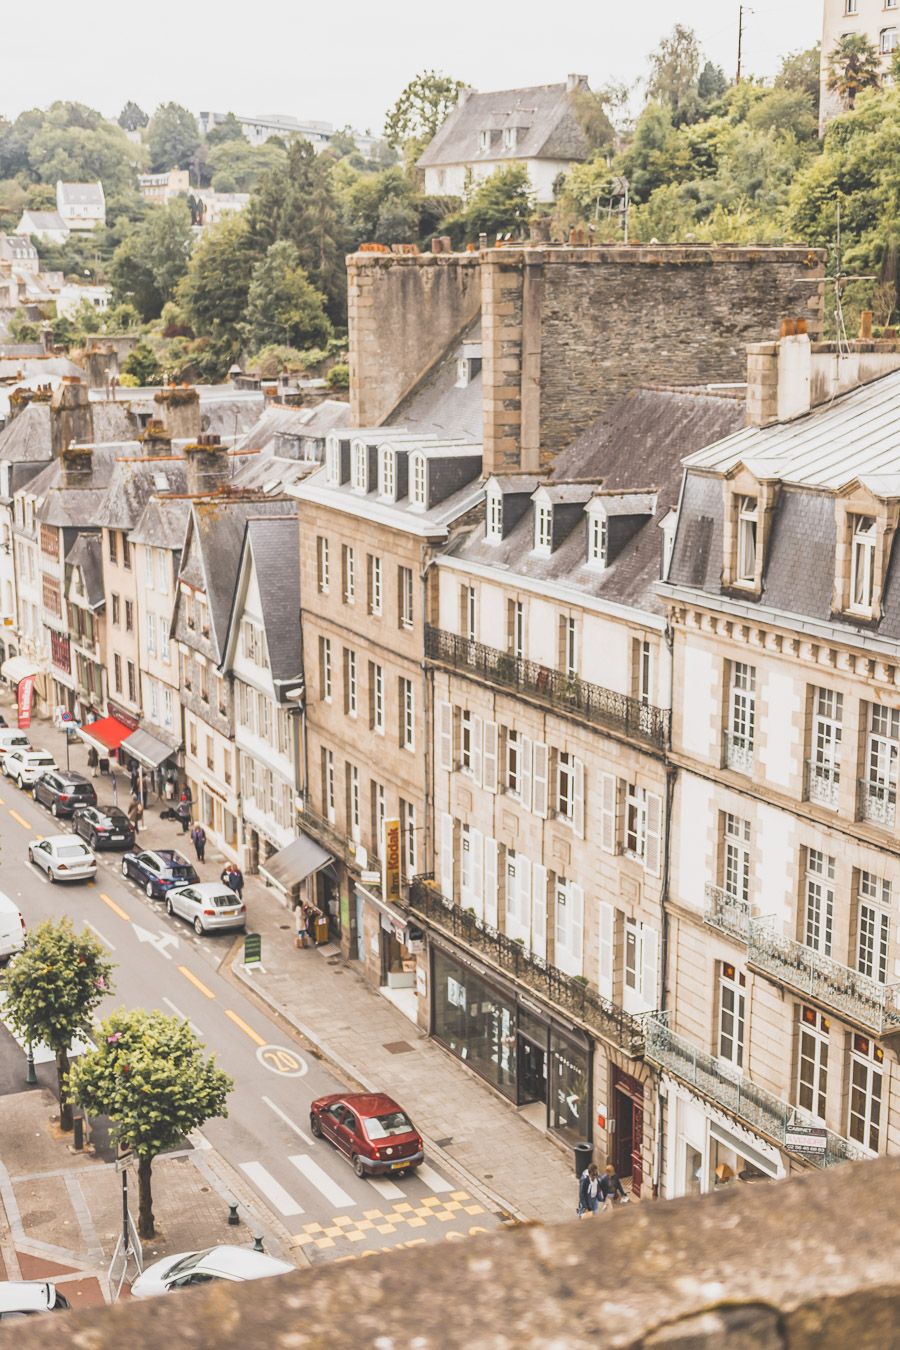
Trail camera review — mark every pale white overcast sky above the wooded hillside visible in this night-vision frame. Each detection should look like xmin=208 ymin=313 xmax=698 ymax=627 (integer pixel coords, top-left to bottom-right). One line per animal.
xmin=0 ymin=0 xmax=823 ymax=131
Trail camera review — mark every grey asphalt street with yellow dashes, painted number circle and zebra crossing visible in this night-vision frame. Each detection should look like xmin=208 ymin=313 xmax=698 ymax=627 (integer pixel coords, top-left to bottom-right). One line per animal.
xmin=0 ymin=761 xmax=501 ymax=1262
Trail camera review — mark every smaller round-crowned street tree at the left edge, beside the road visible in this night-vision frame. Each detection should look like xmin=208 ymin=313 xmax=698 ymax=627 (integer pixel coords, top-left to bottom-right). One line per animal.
xmin=5 ymin=918 xmax=112 ymax=1130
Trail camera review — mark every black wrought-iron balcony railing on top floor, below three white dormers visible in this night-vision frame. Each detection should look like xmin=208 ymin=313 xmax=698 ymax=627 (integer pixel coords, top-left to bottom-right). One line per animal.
xmin=425 ymin=626 xmax=669 ymax=749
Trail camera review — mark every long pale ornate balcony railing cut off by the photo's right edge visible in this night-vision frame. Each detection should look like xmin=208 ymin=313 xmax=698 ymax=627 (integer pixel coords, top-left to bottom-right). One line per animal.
xmin=748 ymin=919 xmax=900 ymax=1035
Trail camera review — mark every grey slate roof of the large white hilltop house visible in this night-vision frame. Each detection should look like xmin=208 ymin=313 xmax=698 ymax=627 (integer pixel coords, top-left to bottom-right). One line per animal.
xmin=418 ymin=84 xmax=590 ymax=169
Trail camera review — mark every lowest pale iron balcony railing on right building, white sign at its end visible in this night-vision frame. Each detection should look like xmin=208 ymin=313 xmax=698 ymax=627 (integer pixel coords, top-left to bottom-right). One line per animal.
xmin=644 ymin=1015 xmax=869 ymax=1166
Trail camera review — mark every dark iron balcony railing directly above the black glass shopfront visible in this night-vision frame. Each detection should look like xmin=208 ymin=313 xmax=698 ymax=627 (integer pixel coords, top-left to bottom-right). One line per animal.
xmin=409 ymin=876 xmax=644 ymax=1056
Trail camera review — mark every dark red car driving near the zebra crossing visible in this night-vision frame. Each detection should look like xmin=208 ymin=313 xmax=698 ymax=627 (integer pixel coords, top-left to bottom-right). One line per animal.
xmin=309 ymin=1092 xmax=425 ymax=1177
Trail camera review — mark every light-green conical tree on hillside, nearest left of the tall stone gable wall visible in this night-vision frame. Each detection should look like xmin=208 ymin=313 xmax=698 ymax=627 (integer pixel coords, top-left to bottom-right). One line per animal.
xmin=244 ymin=239 xmax=332 ymax=351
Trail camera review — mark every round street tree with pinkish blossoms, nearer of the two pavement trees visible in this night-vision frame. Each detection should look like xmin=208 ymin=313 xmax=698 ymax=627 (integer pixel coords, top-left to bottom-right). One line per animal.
xmin=70 ymin=1008 xmax=233 ymax=1238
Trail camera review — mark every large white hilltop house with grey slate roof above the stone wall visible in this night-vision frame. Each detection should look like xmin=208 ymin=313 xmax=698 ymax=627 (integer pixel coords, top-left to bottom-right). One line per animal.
xmin=418 ymin=76 xmax=599 ymax=201
